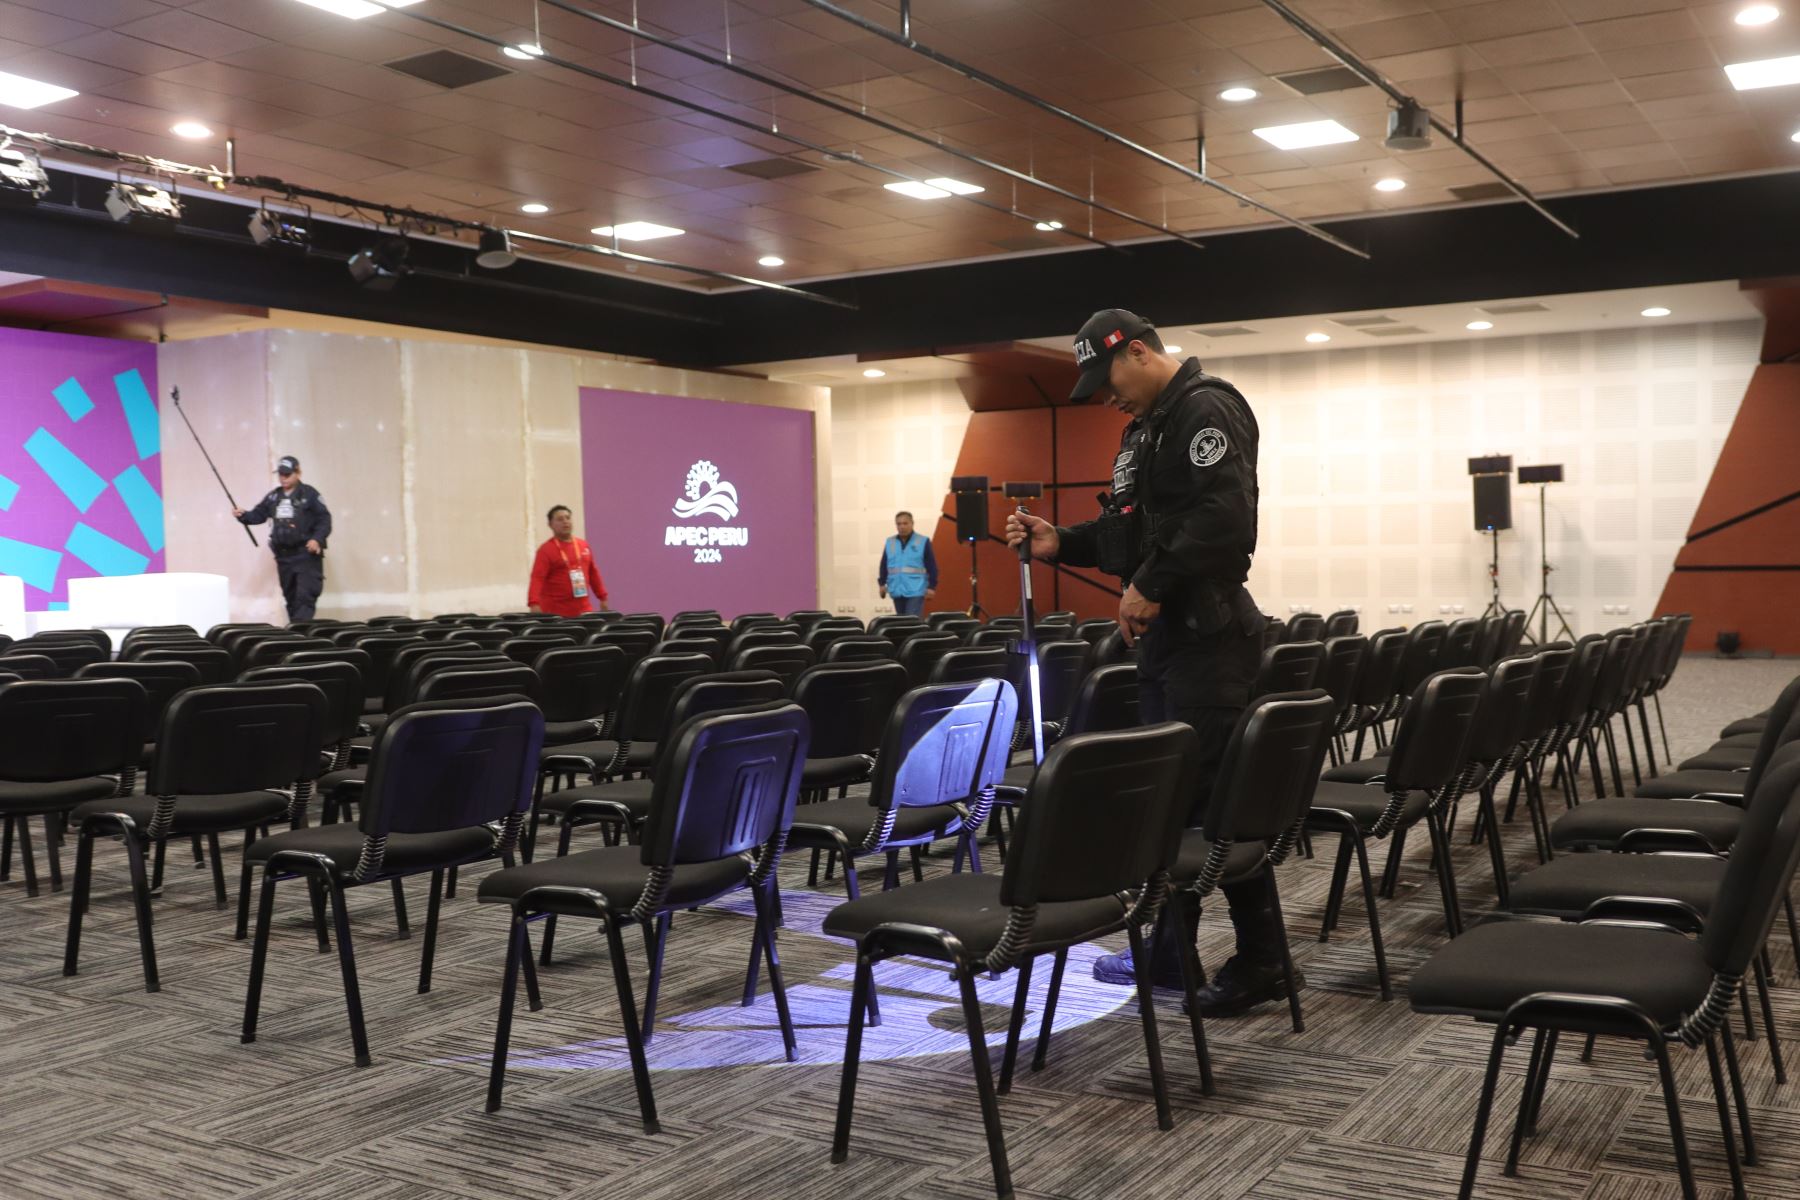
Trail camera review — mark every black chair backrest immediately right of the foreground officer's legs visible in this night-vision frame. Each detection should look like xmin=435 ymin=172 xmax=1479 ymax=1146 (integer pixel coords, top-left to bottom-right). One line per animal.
xmin=1201 ymin=687 xmax=1337 ymax=842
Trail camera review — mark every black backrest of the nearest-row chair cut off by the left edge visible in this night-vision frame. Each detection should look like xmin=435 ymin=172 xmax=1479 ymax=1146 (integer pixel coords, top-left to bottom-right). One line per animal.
xmin=0 ymin=676 xmax=151 ymax=783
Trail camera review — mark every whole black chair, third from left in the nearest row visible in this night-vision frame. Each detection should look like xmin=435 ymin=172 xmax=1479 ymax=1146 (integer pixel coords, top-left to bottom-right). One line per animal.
xmin=241 ymin=700 xmax=544 ymax=1067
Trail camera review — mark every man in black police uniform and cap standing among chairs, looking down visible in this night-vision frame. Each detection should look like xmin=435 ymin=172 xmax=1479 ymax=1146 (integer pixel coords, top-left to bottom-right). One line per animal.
xmin=1006 ymin=308 xmax=1298 ymax=1016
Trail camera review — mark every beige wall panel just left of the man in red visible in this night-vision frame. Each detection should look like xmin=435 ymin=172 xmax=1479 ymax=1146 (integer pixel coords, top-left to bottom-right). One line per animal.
xmin=414 ymin=342 xmax=531 ymax=613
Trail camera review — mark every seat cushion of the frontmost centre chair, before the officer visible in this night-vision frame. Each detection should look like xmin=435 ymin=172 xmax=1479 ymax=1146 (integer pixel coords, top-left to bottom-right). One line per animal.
xmin=824 ymin=874 xmax=1127 ymax=959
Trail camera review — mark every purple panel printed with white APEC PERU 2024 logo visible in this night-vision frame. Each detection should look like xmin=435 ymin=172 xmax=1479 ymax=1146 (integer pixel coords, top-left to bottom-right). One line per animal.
xmin=583 ymin=387 xmax=819 ymax=617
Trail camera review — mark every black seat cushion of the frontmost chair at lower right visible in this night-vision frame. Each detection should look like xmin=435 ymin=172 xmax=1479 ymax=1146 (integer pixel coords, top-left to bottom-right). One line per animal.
xmin=1409 ymin=921 xmax=1712 ymax=1029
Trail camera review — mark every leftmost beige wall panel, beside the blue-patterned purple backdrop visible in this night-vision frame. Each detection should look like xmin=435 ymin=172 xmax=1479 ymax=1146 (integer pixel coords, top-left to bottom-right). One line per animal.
xmin=157 ymin=333 xmax=288 ymax=624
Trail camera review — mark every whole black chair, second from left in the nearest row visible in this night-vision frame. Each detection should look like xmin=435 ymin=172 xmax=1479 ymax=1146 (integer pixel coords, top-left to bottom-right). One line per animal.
xmin=63 ymin=682 xmax=329 ymax=991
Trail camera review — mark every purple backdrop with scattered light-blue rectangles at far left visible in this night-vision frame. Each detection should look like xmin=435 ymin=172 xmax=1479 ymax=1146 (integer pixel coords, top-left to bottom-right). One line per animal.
xmin=0 ymin=329 xmax=164 ymax=610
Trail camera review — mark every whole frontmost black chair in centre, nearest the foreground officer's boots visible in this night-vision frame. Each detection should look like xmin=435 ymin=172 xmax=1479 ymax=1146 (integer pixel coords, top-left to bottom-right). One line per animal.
xmin=824 ymin=719 xmax=1210 ymax=1198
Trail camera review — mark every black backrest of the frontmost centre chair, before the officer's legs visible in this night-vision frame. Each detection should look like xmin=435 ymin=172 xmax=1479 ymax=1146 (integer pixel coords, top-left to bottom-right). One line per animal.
xmin=1001 ymin=721 xmax=1199 ymax=909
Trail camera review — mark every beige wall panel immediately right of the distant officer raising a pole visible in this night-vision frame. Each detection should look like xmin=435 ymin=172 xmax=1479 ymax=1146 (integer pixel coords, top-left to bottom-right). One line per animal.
xmin=268 ymin=329 xmax=409 ymax=619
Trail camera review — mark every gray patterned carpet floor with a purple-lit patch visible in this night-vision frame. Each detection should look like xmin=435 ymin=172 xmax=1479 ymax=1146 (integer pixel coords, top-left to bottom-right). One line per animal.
xmin=0 ymin=657 xmax=1800 ymax=1200
